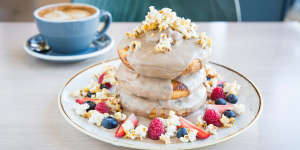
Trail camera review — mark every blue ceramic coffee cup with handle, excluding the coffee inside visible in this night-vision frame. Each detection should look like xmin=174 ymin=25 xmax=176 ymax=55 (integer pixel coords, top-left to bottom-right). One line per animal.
xmin=33 ymin=3 xmax=112 ymax=54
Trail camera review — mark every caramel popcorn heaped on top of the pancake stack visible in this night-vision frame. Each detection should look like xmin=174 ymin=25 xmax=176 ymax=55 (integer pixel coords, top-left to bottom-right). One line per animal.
xmin=126 ymin=6 xmax=211 ymax=53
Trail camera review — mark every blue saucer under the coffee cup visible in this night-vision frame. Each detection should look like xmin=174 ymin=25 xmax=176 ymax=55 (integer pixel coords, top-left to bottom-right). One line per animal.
xmin=24 ymin=34 xmax=114 ymax=62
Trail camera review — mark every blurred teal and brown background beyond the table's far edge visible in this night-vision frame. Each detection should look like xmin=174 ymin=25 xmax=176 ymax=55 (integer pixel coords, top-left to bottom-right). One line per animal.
xmin=0 ymin=0 xmax=300 ymax=22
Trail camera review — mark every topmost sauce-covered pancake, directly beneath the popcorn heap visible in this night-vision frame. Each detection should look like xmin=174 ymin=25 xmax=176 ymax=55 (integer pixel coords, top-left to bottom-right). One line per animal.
xmin=118 ymin=30 xmax=211 ymax=79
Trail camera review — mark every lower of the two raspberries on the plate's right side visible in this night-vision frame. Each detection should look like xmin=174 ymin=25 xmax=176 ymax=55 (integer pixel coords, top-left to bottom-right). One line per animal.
xmin=203 ymin=109 xmax=222 ymax=127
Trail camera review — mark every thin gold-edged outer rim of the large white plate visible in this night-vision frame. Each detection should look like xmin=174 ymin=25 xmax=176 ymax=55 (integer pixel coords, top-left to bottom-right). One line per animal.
xmin=58 ymin=58 xmax=263 ymax=149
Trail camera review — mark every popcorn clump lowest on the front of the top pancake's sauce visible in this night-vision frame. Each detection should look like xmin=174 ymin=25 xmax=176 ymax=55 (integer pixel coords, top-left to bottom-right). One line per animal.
xmin=155 ymin=33 xmax=173 ymax=53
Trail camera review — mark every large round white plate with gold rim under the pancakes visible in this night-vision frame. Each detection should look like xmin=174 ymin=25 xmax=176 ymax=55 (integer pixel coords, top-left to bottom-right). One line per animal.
xmin=58 ymin=59 xmax=262 ymax=149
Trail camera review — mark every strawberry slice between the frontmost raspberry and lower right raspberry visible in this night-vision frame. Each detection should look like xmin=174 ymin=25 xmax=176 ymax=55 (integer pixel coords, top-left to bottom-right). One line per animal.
xmin=179 ymin=117 xmax=210 ymax=139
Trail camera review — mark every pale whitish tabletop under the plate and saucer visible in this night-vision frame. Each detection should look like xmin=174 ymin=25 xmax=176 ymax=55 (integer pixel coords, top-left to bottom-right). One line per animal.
xmin=0 ymin=22 xmax=300 ymax=150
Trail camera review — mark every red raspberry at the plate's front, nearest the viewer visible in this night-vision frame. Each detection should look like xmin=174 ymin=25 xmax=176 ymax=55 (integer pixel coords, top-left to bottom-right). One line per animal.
xmin=148 ymin=118 xmax=165 ymax=140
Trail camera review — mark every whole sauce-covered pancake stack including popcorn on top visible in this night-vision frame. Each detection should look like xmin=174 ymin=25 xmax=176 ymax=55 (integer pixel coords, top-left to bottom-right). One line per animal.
xmin=117 ymin=7 xmax=211 ymax=118
